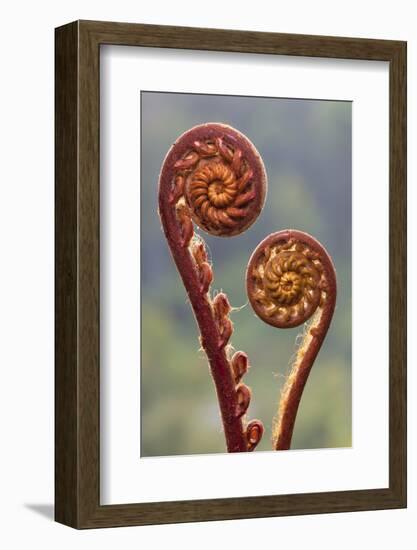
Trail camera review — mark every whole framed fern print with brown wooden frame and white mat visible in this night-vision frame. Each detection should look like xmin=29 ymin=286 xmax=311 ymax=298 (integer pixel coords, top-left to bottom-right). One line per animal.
xmin=55 ymin=21 xmax=406 ymax=528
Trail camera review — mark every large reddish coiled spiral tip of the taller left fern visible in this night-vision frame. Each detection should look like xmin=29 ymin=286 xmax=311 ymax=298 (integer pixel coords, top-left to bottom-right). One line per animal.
xmin=167 ymin=124 xmax=266 ymax=237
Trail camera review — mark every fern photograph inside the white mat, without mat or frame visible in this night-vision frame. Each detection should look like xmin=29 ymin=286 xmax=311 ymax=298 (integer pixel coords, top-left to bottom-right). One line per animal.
xmin=138 ymin=90 xmax=352 ymax=457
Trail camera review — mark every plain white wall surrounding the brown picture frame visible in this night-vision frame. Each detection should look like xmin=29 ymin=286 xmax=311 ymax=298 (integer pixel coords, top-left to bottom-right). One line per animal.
xmin=0 ymin=0 xmax=417 ymax=550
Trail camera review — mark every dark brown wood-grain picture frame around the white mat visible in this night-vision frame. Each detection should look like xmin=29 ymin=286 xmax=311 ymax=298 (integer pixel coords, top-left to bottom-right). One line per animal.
xmin=55 ymin=21 xmax=406 ymax=528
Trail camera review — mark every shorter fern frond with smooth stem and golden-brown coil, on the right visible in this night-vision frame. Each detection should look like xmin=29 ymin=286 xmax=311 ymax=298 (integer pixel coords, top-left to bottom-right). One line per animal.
xmin=246 ymin=230 xmax=337 ymax=451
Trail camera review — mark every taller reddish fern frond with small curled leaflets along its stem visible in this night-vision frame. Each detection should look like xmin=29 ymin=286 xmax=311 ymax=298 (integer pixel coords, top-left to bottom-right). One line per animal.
xmin=159 ymin=123 xmax=266 ymax=452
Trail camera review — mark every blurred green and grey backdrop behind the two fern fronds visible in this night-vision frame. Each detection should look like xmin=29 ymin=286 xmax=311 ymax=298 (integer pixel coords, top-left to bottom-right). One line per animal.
xmin=141 ymin=92 xmax=352 ymax=456
